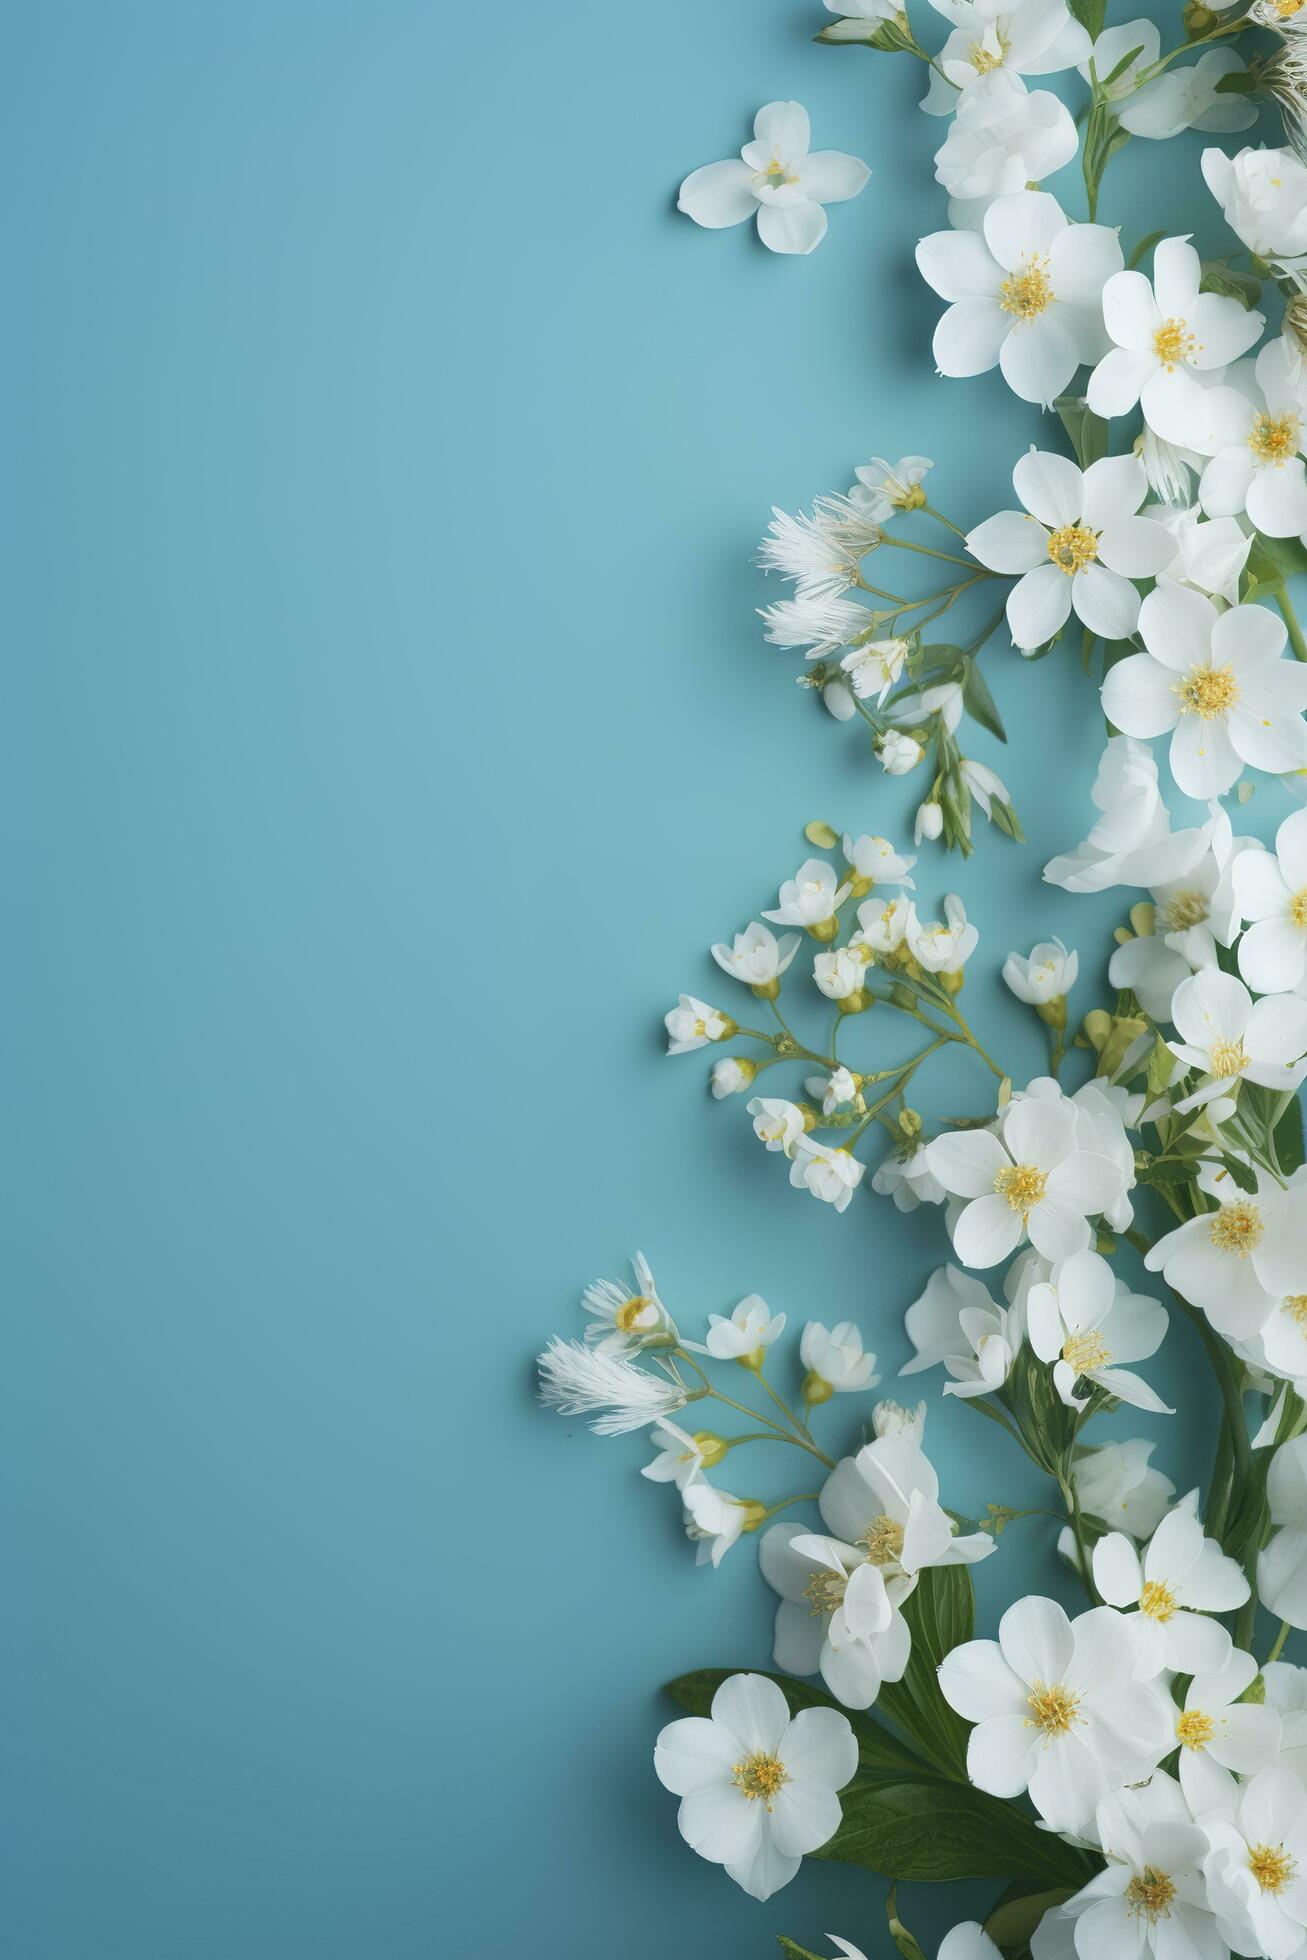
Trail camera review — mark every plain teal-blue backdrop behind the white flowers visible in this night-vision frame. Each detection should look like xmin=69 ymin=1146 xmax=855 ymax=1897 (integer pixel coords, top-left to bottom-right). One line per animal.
xmin=0 ymin=0 xmax=1283 ymax=1960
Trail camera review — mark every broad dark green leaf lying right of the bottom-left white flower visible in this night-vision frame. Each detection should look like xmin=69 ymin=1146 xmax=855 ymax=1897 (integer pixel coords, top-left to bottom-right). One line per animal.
xmin=813 ymin=1778 xmax=1097 ymax=1889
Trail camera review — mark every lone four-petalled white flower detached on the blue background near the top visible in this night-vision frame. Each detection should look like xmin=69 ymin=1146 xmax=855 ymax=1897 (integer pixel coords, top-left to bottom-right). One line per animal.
xmin=676 ymin=102 xmax=872 ymax=253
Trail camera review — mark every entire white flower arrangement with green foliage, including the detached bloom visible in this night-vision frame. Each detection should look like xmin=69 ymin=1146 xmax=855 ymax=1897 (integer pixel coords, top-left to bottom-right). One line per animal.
xmin=541 ymin=0 xmax=1307 ymax=1960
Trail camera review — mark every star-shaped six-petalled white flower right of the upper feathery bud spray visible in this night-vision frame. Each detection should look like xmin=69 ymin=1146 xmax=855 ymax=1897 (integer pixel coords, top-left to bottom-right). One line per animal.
xmin=966 ymin=449 xmax=1176 ymax=651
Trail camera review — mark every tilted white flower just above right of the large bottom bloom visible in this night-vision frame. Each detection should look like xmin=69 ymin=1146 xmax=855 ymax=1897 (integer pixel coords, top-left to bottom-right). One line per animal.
xmin=1093 ymin=1492 xmax=1248 ymax=1680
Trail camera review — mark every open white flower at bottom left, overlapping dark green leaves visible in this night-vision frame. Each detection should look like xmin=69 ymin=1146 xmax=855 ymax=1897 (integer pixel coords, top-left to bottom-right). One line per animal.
xmin=654 ymin=1674 xmax=858 ymax=1899
